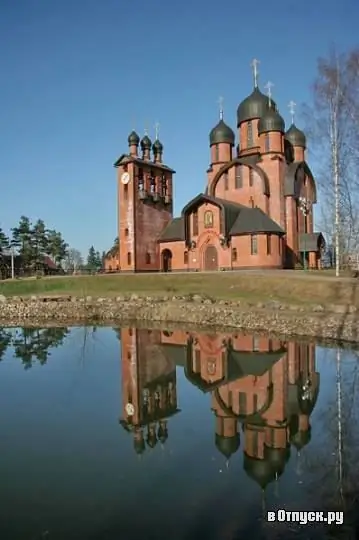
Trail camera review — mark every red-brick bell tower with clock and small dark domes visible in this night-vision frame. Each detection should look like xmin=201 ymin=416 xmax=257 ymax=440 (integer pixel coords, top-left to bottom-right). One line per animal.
xmin=114 ymin=124 xmax=175 ymax=272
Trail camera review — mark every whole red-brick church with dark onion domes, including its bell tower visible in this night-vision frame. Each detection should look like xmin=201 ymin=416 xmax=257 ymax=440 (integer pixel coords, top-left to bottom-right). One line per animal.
xmin=105 ymin=60 xmax=324 ymax=273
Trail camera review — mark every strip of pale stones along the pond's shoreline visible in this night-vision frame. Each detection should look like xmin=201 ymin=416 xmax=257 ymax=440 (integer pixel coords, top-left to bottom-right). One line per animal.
xmin=0 ymin=294 xmax=359 ymax=342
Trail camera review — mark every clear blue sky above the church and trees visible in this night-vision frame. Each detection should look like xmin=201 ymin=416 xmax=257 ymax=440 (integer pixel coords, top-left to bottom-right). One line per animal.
xmin=0 ymin=0 xmax=359 ymax=258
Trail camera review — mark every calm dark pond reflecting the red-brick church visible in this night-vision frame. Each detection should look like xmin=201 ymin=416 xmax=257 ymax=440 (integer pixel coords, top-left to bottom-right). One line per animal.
xmin=0 ymin=327 xmax=359 ymax=540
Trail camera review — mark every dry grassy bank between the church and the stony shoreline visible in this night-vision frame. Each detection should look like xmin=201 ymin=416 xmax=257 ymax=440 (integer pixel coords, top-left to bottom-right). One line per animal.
xmin=0 ymin=272 xmax=359 ymax=307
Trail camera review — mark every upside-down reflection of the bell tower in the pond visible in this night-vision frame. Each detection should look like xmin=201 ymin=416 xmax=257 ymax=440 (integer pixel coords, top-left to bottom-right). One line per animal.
xmin=120 ymin=328 xmax=178 ymax=454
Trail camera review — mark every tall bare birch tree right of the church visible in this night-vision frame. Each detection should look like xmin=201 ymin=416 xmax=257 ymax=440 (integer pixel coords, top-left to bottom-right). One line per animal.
xmin=305 ymin=48 xmax=359 ymax=274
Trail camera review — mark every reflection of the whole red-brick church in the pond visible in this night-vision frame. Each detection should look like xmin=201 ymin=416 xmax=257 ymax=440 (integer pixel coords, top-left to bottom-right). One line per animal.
xmin=120 ymin=328 xmax=319 ymax=488
